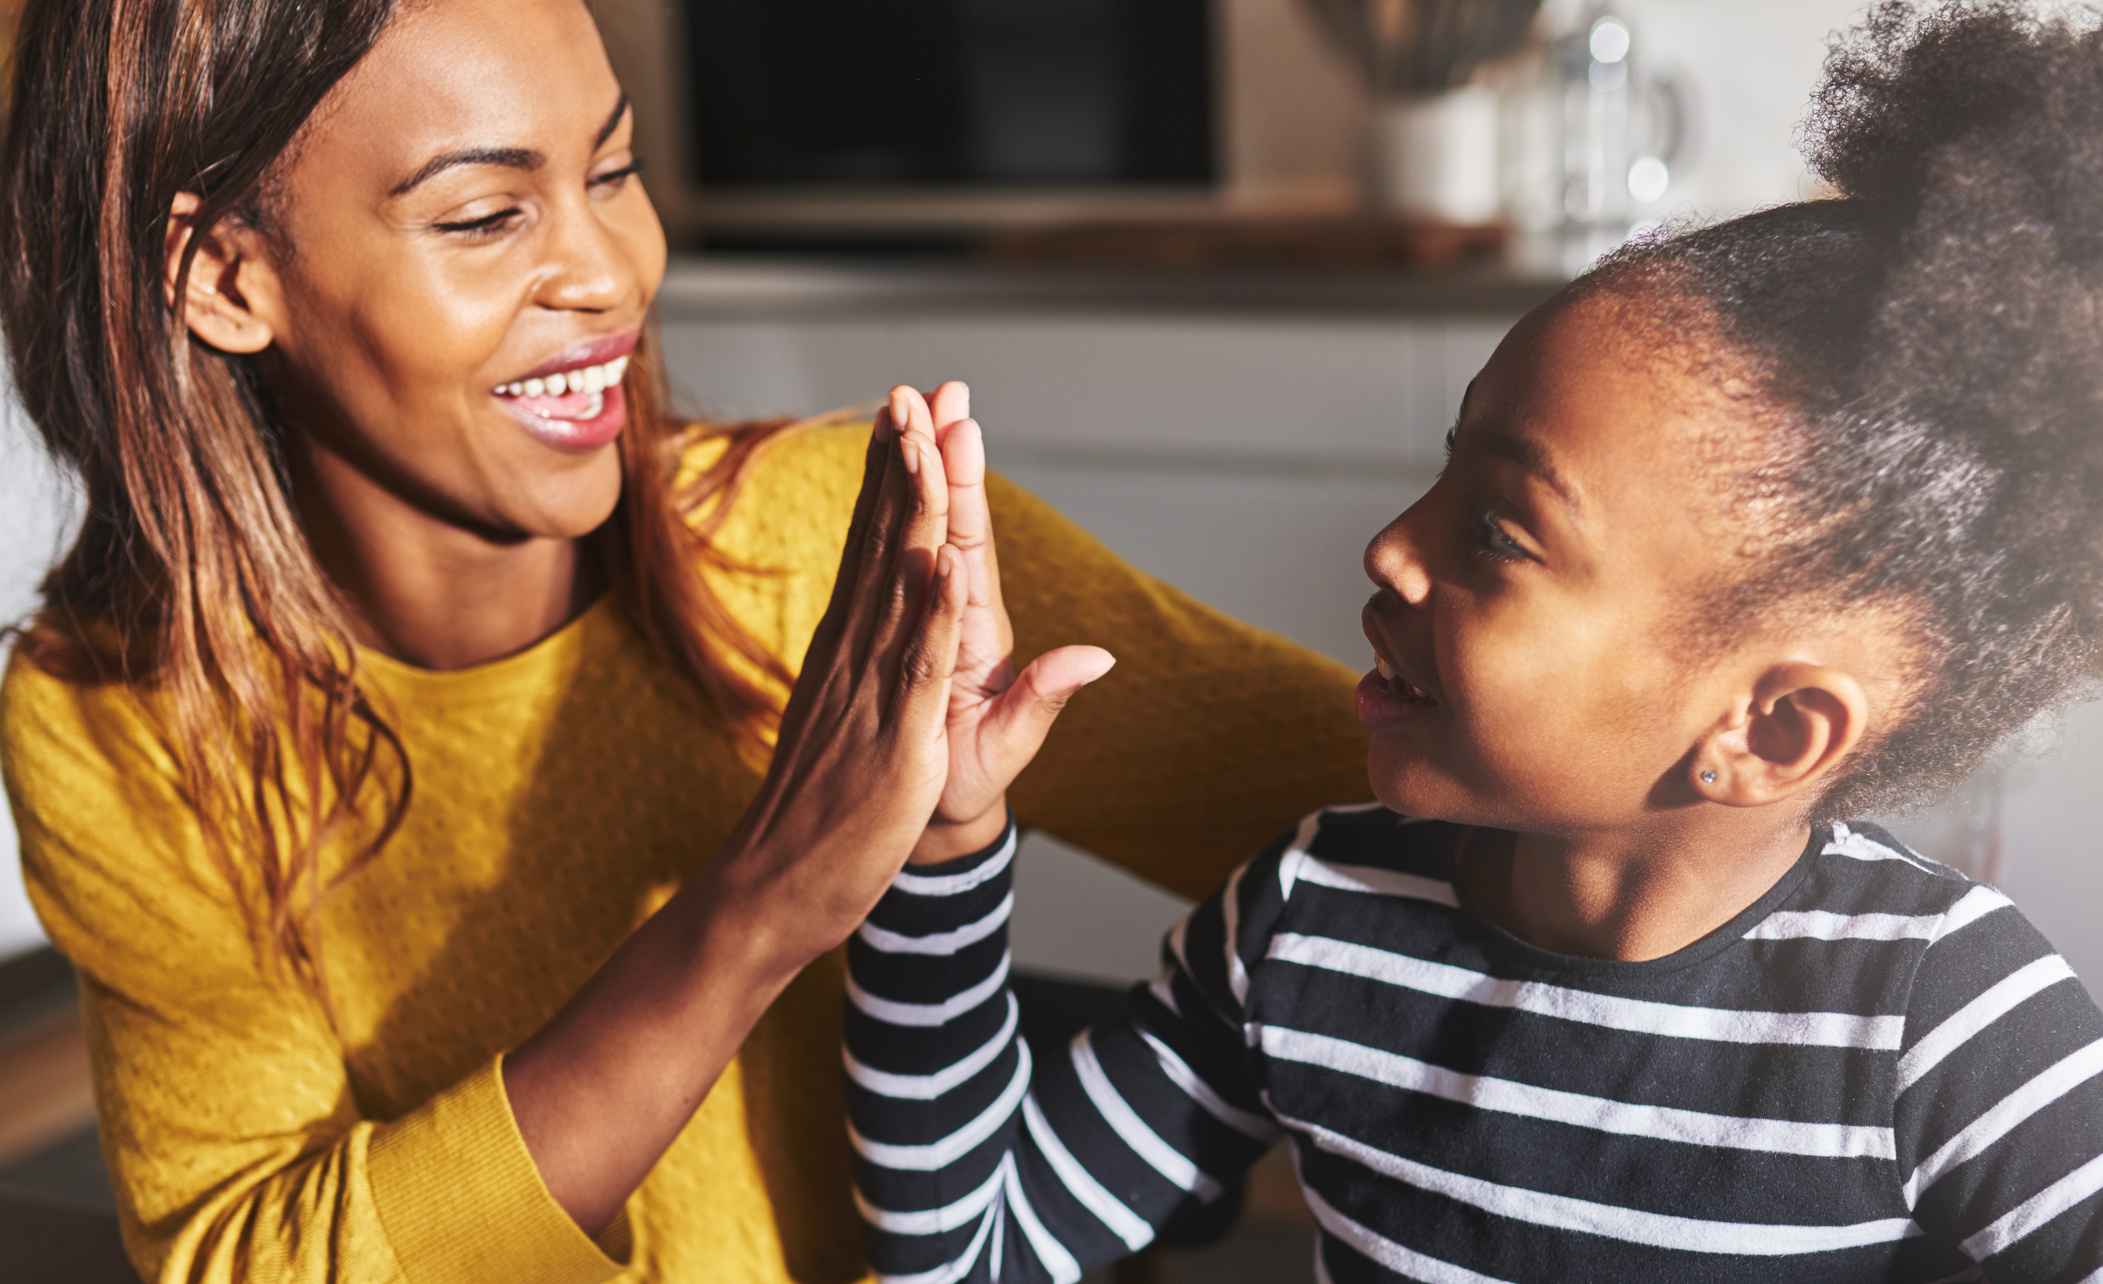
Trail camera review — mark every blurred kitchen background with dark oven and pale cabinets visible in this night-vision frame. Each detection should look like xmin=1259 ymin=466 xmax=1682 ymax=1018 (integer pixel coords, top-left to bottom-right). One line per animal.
xmin=0 ymin=0 xmax=2103 ymax=1280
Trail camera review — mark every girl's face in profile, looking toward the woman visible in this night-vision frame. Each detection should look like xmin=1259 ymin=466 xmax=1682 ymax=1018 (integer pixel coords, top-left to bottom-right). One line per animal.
xmin=1359 ymin=287 xmax=1825 ymax=834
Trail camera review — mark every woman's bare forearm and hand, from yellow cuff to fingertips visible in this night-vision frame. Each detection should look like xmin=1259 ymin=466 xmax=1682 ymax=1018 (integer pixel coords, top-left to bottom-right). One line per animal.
xmin=503 ymin=407 xmax=967 ymax=1231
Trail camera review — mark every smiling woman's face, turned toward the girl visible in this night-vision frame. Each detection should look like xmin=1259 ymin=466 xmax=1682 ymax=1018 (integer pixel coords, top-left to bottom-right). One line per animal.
xmin=240 ymin=0 xmax=665 ymax=542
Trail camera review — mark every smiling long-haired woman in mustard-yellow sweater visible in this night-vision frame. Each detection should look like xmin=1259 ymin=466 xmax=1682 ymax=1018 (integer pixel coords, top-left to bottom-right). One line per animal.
xmin=0 ymin=0 xmax=1363 ymax=1280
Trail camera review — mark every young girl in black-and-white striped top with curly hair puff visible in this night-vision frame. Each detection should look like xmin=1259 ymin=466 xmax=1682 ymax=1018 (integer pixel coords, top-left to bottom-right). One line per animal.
xmin=848 ymin=4 xmax=2103 ymax=1284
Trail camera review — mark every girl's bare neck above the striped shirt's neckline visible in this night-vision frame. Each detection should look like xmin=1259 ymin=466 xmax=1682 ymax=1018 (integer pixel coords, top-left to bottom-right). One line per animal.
xmin=1455 ymin=811 xmax=1811 ymax=962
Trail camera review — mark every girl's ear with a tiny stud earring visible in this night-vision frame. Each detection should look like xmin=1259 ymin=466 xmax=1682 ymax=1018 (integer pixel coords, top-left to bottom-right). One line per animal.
xmin=1687 ymin=662 xmax=1870 ymax=807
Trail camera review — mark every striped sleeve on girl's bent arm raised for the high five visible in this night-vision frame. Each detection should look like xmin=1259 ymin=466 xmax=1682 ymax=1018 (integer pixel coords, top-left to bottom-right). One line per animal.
xmin=845 ymin=824 xmax=1285 ymax=1284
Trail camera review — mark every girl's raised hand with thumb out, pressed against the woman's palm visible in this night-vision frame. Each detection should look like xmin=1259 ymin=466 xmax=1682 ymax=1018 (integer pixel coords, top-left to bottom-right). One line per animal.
xmin=895 ymin=382 xmax=1117 ymax=864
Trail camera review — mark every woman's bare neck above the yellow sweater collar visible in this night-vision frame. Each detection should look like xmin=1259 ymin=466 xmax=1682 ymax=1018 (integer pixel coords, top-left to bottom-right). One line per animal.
xmin=292 ymin=432 xmax=606 ymax=670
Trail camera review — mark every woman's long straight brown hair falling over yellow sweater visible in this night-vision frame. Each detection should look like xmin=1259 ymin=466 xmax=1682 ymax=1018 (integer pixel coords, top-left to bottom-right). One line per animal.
xmin=0 ymin=0 xmax=789 ymax=1000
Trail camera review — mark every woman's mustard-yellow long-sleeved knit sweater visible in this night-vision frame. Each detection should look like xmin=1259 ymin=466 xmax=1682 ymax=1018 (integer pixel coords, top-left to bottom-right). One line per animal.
xmin=0 ymin=424 xmax=1367 ymax=1284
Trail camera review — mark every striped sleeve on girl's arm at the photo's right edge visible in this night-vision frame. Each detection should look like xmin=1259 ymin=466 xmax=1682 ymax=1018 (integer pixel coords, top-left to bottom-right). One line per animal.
xmin=1893 ymin=887 xmax=2103 ymax=1282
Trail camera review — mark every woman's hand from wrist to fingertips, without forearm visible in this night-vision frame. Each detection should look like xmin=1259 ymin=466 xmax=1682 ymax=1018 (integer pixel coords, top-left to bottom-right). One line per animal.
xmin=715 ymin=401 xmax=969 ymax=967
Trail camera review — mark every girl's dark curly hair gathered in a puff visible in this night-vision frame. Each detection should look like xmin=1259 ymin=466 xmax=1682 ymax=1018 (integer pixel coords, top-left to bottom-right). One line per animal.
xmin=1579 ymin=0 xmax=2103 ymax=817
